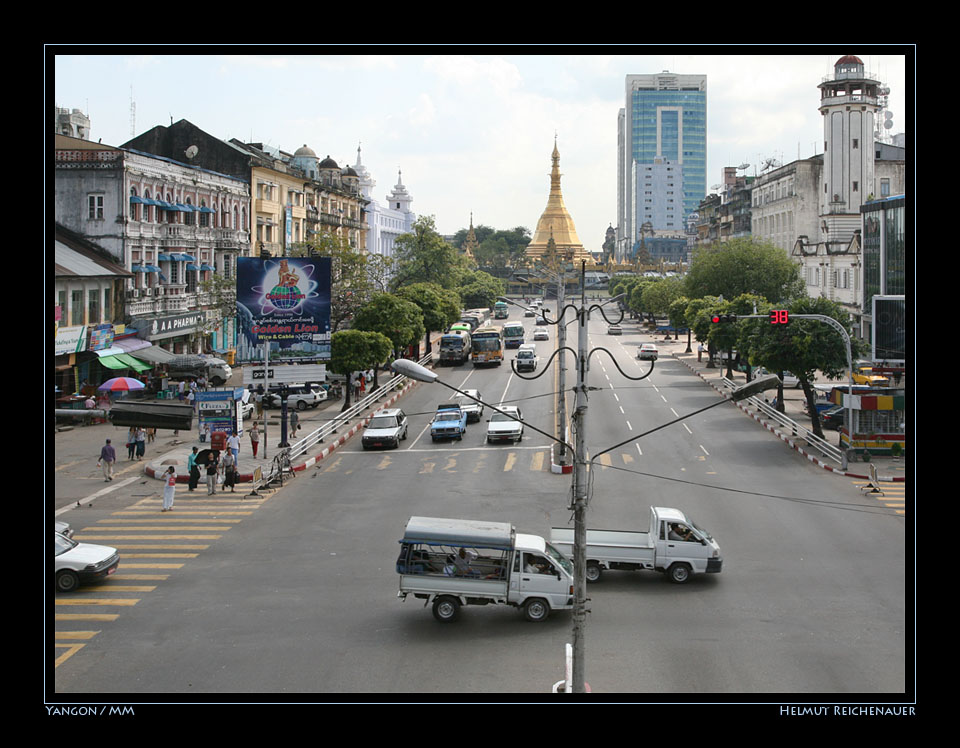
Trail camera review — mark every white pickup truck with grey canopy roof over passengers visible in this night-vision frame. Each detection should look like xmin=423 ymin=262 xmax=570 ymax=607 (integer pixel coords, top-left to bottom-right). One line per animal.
xmin=397 ymin=517 xmax=573 ymax=623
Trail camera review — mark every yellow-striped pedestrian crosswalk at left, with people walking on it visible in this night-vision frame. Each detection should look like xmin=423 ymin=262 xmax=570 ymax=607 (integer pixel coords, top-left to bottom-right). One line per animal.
xmin=54 ymin=483 xmax=272 ymax=667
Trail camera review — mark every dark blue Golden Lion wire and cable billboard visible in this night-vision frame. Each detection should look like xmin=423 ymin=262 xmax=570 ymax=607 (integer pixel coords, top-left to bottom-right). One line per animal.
xmin=237 ymin=257 xmax=331 ymax=361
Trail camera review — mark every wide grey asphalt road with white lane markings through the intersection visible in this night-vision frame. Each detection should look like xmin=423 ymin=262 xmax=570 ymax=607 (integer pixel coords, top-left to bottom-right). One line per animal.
xmin=55 ymin=306 xmax=907 ymax=701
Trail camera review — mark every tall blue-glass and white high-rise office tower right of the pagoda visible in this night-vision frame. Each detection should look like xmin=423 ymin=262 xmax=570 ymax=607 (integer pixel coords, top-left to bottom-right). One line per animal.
xmin=617 ymin=71 xmax=707 ymax=259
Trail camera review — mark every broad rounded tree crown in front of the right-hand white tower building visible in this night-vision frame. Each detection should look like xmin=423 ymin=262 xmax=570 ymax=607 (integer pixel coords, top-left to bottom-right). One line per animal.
xmin=685 ymin=237 xmax=804 ymax=304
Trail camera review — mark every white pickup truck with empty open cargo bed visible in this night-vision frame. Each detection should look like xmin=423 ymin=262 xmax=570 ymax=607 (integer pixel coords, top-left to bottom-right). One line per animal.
xmin=550 ymin=506 xmax=723 ymax=584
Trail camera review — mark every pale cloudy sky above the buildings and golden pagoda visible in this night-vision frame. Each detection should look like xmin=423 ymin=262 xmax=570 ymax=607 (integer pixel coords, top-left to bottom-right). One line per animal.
xmin=47 ymin=51 xmax=914 ymax=250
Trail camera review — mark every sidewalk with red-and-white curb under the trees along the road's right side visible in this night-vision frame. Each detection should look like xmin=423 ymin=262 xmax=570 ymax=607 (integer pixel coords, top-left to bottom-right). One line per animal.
xmin=640 ymin=332 xmax=907 ymax=481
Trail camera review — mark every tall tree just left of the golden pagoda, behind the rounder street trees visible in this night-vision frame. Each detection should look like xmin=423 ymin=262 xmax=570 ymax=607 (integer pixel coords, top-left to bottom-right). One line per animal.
xmin=390 ymin=216 xmax=467 ymax=291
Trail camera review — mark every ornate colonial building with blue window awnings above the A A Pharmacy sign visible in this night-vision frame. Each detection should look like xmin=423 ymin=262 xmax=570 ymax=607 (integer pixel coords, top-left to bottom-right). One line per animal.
xmin=54 ymin=135 xmax=250 ymax=353
